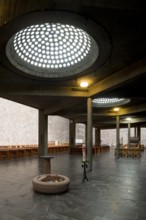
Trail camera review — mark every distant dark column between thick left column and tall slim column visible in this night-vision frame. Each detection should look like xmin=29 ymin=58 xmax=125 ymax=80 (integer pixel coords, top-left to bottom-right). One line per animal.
xmin=69 ymin=120 xmax=76 ymax=153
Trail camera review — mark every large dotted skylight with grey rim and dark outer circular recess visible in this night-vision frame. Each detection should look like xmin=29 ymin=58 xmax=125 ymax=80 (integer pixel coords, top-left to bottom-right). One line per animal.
xmin=1 ymin=11 xmax=111 ymax=79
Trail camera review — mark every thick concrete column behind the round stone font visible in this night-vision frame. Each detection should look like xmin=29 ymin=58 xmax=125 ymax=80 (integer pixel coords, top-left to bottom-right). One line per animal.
xmin=38 ymin=110 xmax=48 ymax=156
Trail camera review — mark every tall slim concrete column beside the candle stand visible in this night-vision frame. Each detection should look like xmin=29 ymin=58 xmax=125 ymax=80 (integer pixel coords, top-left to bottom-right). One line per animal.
xmin=87 ymin=98 xmax=92 ymax=171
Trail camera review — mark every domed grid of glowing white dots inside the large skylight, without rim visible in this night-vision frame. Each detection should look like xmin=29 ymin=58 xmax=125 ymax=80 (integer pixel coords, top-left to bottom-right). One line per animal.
xmin=14 ymin=23 xmax=91 ymax=69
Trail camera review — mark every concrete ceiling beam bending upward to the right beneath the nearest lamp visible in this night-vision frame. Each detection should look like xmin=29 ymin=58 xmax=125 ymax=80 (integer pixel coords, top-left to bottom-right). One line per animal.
xmin=0 ymin=59 xmax=146 ymax=97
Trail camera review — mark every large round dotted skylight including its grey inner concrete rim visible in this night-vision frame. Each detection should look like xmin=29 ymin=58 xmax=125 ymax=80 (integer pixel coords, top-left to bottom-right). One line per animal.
xmin=6 ymin=23 xmax=98 ymax=78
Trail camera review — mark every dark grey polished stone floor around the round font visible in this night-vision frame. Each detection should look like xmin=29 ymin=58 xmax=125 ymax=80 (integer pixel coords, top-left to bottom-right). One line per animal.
xmin=0 ymin=150 xmax=146 ymax=220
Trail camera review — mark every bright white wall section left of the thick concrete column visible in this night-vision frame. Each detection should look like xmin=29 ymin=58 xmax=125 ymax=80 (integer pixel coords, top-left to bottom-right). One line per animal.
xmin=0 ymin=98 xmax=38 ymax=145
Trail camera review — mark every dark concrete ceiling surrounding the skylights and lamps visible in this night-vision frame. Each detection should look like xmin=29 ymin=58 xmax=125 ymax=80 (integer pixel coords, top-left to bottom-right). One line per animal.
xmin=0 ymin=0 xmax=146 ymax=128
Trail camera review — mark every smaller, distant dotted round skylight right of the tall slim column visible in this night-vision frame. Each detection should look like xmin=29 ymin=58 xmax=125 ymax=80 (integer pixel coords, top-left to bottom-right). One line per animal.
xmin=92 ymin=98 xmax=130 ymax=107
